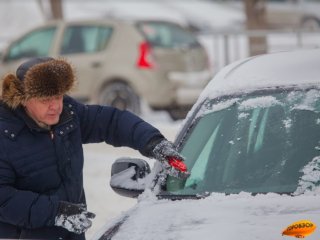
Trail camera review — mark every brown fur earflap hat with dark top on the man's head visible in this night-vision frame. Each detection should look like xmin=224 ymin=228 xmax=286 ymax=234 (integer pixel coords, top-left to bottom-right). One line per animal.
xmin=2 ymin=57 xmax=75 ymax=108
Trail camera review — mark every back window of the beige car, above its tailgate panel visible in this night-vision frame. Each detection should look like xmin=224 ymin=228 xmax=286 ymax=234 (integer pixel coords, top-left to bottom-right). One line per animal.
xmin=137 ymin=22 xmax=200 ymax=48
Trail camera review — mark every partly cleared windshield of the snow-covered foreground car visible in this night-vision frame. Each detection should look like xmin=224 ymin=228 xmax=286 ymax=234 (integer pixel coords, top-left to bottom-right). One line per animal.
xmin=166 ymin=89 xmax=320 ymax=195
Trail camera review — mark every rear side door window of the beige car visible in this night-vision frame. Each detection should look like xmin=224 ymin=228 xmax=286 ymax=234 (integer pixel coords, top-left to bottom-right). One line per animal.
xmin=60 ymin=26 xmax=112 ymax=54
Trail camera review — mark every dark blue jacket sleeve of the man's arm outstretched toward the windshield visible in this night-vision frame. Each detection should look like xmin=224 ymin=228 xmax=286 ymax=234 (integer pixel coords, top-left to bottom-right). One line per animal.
xmin=70 ymin=97 xmax=164 ymax=154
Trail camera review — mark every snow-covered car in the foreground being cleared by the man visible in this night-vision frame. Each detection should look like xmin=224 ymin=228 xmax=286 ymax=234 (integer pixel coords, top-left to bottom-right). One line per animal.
xmin=95 ymin=50 xmax=320 ymax=240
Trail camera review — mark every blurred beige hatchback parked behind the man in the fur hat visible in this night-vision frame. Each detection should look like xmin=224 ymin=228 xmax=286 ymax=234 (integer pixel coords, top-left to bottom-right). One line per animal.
xmin=0 ymin=19 xmax=211 ymax=119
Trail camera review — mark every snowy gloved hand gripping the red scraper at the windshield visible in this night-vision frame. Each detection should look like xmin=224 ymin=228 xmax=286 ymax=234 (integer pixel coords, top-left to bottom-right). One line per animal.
xmin=152 ymin=139 xmax=190 ymax=179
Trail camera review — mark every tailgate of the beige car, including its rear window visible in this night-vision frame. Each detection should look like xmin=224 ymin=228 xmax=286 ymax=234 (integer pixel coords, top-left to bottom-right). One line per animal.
xmin=137 ymin=21 xmax=209 ymax=83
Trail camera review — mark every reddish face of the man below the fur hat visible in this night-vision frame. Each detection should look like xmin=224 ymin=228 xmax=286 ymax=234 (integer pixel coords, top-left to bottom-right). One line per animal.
xmin=24 ymin=96 xmax=63 ymax=126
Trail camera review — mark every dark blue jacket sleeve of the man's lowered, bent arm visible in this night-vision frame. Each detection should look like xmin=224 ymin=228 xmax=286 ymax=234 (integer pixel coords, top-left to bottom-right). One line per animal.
xmin=0 ymin=156 xmax=58 ymax=229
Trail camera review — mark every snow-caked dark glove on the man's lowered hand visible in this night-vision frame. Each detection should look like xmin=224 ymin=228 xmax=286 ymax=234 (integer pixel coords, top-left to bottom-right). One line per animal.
xmin=55 ymin=201 xmax=96 ymax=234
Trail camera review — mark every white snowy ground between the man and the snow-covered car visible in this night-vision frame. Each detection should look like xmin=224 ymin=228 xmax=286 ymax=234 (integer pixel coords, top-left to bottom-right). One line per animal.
xmin=84 ymin=108 xmax=181 ymax=239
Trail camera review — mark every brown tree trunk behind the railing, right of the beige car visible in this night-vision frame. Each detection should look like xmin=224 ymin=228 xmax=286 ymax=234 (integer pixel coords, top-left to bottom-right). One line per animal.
xmin=244 ymin=0 xmax=268 ymax=56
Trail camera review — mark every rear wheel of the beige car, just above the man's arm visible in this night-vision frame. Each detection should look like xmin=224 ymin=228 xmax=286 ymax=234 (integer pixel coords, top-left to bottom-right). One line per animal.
xmin=99 ymin=82 xmax=141 ymax=114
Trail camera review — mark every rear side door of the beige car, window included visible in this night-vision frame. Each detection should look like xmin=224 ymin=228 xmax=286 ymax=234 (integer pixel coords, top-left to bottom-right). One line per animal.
xmin=59 ymin=23 xmax=112 ymax=101
